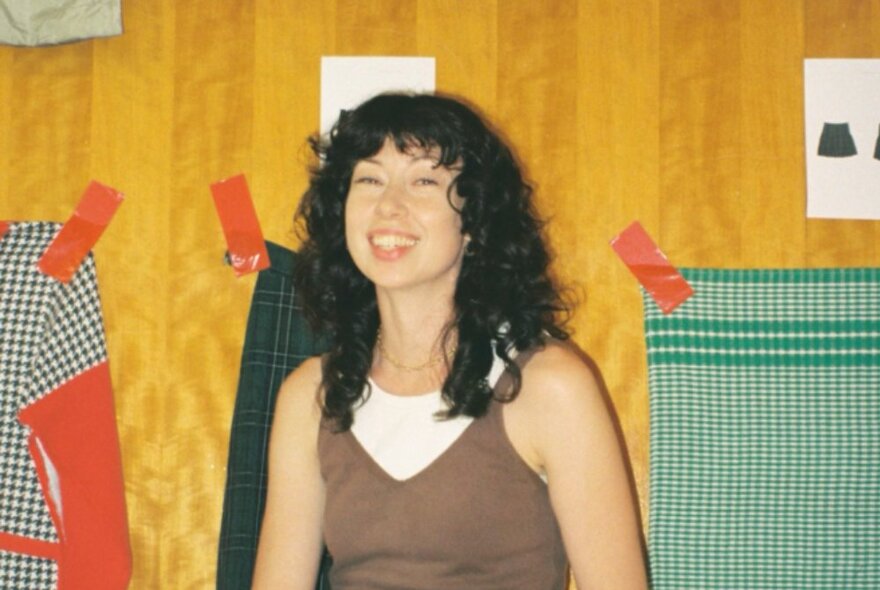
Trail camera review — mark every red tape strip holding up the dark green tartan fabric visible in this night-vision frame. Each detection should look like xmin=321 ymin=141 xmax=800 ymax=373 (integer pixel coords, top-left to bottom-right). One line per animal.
xmin=211 ymin=174 xmax=269 ymax=276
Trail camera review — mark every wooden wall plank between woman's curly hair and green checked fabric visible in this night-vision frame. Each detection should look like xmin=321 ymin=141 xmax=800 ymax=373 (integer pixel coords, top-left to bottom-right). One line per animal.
xmin=576 ymin=0 xmax=660 ymax=519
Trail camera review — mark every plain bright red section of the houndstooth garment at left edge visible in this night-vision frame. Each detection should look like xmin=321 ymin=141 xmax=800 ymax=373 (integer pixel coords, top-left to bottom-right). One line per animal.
xmin=18 ymin=363 xmax=132 ymax=590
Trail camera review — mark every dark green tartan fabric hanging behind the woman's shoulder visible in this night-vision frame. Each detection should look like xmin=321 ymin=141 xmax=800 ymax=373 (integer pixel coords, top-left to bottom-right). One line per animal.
xmin=217 ymin=242 xmax=327 ymax=590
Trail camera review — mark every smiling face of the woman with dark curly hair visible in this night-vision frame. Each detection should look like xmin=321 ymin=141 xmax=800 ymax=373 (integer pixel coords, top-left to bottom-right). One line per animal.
xmin=345 ymin=140 xmax=465 ymax=294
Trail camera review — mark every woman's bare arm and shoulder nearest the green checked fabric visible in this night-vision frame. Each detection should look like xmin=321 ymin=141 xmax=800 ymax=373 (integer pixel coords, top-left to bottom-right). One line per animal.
xmin=511 ymin=343 xmax=648 ymax=590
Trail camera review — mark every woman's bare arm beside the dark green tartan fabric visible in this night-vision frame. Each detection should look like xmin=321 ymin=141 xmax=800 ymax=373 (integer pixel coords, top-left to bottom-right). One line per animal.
xmin=252 ymin=358 xmax=324 ymax=590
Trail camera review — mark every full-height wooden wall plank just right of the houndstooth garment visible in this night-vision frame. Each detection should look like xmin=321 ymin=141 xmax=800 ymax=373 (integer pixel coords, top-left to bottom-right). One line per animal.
xmin=89 ymin=0 xmax=176 ymax=588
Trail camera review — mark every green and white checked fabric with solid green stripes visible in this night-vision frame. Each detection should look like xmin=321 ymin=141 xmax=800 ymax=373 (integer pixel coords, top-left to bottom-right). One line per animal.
xmin=644 ymin=268 xmax=880 ymax=590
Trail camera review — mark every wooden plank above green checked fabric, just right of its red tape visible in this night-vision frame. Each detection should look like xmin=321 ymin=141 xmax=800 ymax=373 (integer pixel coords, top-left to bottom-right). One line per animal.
xmin=660 ymin=0 xmax=742 ymax=267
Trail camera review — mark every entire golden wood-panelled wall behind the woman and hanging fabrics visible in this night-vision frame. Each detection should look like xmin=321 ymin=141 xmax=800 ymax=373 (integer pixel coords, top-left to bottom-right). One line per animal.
xmin=0 ymin=0 xmax=880 ymax=589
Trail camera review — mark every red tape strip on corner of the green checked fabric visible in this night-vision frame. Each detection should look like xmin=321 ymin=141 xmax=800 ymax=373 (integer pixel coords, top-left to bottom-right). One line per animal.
xmin=611 ymin=221 xmax=694 ymax=313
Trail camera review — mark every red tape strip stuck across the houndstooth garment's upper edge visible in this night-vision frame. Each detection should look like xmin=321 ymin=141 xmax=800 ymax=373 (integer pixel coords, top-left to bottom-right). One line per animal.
xmin=37 ymin=180 xmax=123 ymax=283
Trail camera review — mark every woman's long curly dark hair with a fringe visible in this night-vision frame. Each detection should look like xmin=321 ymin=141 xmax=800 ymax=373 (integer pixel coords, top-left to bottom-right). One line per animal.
xmin=296 ymin=94 xmax=568 ymax=430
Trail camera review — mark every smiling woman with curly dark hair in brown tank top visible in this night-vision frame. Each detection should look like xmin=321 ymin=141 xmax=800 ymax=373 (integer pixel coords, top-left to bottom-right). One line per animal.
xmin=254 ymin=95 xmax=646 ymax=590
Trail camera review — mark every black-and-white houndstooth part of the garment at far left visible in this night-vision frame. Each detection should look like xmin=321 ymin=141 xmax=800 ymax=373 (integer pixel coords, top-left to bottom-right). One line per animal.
xmin=0 ymin=222 xmax=107 ymax=590
